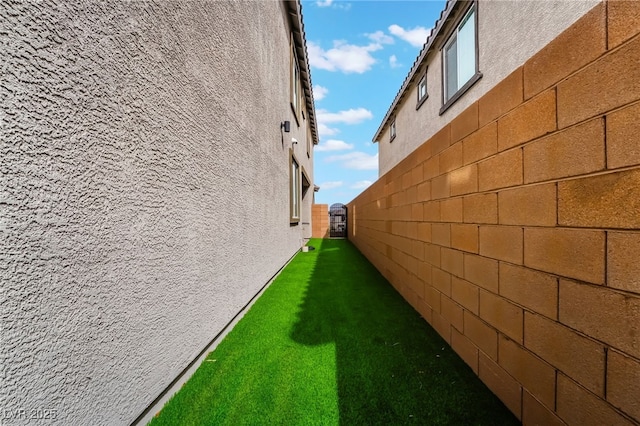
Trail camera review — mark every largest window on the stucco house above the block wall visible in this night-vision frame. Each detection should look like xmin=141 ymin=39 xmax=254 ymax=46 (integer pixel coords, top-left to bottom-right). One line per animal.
xmin=440 ymin=5 xmax=482 ymax=110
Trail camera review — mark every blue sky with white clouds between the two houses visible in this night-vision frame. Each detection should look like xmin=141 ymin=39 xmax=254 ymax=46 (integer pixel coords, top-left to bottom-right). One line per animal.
xmin=302 ymin=0 xmax=445 ymax=204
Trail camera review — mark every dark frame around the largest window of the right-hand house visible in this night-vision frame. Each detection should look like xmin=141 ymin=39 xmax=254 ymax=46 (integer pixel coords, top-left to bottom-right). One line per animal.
xmin=439 ymin=1 xmax=482 ymax=115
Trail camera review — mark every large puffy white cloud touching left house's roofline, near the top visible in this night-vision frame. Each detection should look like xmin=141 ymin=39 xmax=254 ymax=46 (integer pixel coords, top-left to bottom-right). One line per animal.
xmin=307 ymin=40 xmax=382 ymax=74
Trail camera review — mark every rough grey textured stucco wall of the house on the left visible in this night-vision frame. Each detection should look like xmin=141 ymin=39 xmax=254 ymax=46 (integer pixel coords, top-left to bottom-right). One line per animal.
xmin=0 ymin=1 xmax=313 ymax=425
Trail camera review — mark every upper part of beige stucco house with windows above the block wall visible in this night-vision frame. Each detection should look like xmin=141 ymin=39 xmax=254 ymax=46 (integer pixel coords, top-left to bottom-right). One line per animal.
xmin=373 ymin=0 xmax=599 ymax=176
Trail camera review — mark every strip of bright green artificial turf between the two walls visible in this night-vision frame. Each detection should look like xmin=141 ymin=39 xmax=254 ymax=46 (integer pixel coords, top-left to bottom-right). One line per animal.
xmin=151 ymin=240 xmax=518 ymax=426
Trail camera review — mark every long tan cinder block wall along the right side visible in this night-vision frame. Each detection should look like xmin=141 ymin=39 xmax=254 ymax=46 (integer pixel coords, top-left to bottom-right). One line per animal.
xmin=349 ymin=1 xmax=640 ymax=425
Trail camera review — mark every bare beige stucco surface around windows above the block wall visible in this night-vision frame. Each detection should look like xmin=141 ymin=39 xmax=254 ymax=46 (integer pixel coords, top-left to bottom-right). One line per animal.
xmin=378 ymin=0 xmax=600 ymax=176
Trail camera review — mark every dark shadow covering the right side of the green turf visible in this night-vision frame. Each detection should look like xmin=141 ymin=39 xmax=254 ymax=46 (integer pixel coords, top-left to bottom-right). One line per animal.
xmin=291 ymin=240 xmax=519 ymax=425
